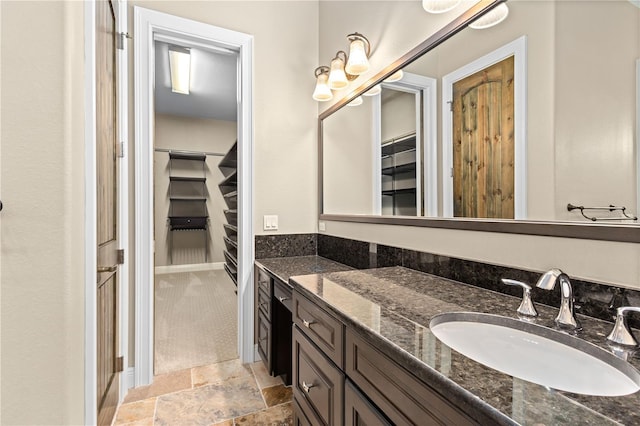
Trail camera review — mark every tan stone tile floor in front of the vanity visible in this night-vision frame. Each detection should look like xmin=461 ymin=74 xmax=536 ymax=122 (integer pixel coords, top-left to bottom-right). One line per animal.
xmin=113 ymin=359 xmax=293 ymax=426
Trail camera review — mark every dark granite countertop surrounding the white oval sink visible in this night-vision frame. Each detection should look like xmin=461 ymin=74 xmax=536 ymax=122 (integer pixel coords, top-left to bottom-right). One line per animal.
xmin=292 ymin=260 xmax=640 ymax=426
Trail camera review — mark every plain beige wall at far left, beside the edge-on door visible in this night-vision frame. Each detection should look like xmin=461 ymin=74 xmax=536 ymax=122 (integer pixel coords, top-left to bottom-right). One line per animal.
xmin=0 ymin=1 xmax=85 ymax=425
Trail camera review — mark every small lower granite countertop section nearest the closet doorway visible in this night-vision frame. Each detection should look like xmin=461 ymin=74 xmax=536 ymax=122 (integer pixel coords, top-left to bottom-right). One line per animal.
xmin=256 ymin=256 xmax=353 ymax=284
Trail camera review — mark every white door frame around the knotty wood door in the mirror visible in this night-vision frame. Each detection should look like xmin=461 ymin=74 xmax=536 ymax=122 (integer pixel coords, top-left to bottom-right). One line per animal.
xmin=442 ymin=36 xmax=527 ymax=219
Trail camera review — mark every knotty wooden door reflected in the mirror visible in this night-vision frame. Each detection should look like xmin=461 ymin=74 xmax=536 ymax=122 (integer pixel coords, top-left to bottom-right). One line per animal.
xmin=453 ymin=56 xmax=514 ymax=219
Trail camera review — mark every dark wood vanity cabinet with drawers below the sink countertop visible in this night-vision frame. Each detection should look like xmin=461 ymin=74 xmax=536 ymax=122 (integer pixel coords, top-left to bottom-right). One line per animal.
xmin=292 ymin=291 xmax=485 ymax=426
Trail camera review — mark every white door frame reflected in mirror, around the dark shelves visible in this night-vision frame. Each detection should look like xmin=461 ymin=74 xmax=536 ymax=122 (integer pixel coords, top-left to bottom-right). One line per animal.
xmin=372 ymin=72 xmax=438 ymax=217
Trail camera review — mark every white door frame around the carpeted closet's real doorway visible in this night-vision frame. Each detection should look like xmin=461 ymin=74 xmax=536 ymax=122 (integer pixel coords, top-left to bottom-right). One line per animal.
xmin=133 ymin=7 xmax=254 ymax=386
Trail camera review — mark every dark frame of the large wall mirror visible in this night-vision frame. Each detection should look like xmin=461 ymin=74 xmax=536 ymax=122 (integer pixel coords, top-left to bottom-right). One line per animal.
xmin=318 ymin=0 xmax=640 ymax=243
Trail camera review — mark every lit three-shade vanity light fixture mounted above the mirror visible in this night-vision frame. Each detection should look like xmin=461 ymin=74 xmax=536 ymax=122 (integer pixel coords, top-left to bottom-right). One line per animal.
xmin=313 ymin=33 xmax=371 ymax=101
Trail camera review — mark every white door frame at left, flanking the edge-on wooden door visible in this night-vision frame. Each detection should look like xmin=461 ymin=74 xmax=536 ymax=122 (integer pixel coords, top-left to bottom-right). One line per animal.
xmin=84 ymin=0 xmax=129 ymax=424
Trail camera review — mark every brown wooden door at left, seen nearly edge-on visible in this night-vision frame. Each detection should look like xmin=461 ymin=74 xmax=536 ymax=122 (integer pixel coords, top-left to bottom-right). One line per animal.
xmin=96 ymin=1 xmax=121 ymax=425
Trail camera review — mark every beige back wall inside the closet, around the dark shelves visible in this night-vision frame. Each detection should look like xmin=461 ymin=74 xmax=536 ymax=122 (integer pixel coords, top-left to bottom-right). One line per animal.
xmin=154 ymin=114 xmax=237 ymax=266
